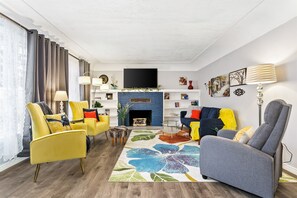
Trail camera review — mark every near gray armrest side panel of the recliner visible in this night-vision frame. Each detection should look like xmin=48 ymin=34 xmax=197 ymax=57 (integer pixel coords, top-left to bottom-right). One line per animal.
xmin=200 ymin=136 xmax=274 ymax=195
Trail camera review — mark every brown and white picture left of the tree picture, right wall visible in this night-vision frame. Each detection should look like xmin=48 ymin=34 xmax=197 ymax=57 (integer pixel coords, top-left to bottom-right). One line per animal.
xmin=210 ymin=74 xmax=230 ymax=97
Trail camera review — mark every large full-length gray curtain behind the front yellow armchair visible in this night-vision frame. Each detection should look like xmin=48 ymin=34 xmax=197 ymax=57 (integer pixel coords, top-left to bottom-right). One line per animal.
xmin=18 ymin=30 xmax=69 ymax=156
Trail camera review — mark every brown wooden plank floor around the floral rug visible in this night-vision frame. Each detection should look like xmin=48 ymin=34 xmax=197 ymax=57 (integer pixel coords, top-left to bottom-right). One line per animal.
xmin=0 ymin=134 xmax=297 ymax=198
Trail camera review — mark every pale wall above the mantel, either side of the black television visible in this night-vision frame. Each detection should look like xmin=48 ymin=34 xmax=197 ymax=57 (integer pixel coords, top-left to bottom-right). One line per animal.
xmin=92 ymin=69 xmax=198 ymax=89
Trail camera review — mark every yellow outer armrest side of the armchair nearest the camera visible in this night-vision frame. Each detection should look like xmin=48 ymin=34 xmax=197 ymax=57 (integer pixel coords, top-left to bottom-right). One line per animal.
xmin=30 ymin=130 xmax=86 ymax=164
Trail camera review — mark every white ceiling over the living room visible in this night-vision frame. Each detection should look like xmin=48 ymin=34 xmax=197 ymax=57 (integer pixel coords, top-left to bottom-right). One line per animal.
xmin=0 ymin=0 xmax=297 ymax=69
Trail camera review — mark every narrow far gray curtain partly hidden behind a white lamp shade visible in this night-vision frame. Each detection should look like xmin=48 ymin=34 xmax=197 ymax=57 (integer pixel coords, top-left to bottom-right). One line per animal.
xmin=79 ymin=60 xmax=91 ymax=101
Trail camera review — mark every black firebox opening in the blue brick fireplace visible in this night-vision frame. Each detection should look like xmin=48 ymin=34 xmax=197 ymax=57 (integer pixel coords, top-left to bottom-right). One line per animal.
xmin=129 ymin=110 xmax=152 ymax=126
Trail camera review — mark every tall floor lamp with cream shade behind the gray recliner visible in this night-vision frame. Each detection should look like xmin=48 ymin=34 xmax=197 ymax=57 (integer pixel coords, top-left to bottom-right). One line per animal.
xmin=246 ymin=64 xmax=276 ymax=126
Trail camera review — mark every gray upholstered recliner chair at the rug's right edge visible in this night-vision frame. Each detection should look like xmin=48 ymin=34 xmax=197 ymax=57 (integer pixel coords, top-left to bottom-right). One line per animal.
xmin=200 ymin=100 xmax=292 ymax=197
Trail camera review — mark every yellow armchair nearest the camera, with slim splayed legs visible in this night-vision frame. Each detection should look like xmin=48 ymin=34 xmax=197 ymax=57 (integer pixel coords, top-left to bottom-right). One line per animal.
xmin=27 ymin=103 xmax=87 ymax=182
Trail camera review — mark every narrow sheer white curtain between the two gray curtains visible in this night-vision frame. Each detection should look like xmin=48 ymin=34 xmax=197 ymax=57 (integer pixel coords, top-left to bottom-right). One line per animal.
xmin=68 ymin=55 xmax=80 ymax=120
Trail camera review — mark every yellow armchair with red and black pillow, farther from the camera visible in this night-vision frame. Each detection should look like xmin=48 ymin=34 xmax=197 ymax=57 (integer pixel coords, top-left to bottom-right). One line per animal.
xmin=69 ymin=101 xmax=110 ymax=140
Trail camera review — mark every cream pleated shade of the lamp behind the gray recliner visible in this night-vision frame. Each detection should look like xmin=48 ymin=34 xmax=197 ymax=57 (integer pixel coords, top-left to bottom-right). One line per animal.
xmin=246 ymin=64 xmax=276 ymax=84
